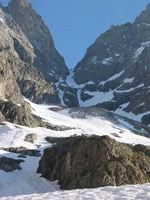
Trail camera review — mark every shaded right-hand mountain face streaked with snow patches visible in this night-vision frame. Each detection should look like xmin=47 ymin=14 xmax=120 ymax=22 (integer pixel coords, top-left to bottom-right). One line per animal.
xmin=74 ymin=5 xmax=150 ymax=122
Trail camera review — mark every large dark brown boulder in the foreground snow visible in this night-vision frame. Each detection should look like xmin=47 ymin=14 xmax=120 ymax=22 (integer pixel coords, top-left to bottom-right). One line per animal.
xmin=37 ymin=136 xmax=150 ymax=189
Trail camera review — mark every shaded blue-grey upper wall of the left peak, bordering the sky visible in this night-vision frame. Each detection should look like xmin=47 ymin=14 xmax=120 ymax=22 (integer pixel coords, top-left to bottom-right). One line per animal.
xmin=8 ymin=0 xmax=69 ymax=83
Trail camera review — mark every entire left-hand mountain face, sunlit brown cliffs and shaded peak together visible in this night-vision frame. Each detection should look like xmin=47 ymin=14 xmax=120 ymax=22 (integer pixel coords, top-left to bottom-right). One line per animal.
xmin=0 ymin=0 xmax=78 ymax=106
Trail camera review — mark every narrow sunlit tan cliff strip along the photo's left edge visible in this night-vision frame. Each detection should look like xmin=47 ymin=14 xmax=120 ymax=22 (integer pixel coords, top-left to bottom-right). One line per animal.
xmin=0 ymin=7 xmax=23 ymax=103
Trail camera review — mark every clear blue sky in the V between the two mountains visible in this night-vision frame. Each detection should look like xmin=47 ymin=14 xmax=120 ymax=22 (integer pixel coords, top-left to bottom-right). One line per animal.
xmin=1 ymin=0 xmax=150 ymax=67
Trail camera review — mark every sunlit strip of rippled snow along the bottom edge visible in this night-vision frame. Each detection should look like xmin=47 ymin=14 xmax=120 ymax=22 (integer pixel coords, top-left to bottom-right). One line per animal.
xmin=1 ymin=184 xmax=150 ymax=200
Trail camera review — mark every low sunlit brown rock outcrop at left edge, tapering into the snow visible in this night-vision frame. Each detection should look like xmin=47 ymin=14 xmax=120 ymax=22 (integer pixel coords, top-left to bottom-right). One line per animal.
xmin=0 ymin=100 xmax=73 ymax=130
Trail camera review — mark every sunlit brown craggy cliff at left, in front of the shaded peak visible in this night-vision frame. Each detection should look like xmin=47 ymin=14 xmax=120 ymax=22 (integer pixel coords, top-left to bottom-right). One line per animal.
xmin=0 ymin=3 xmax=59 ymax=103
